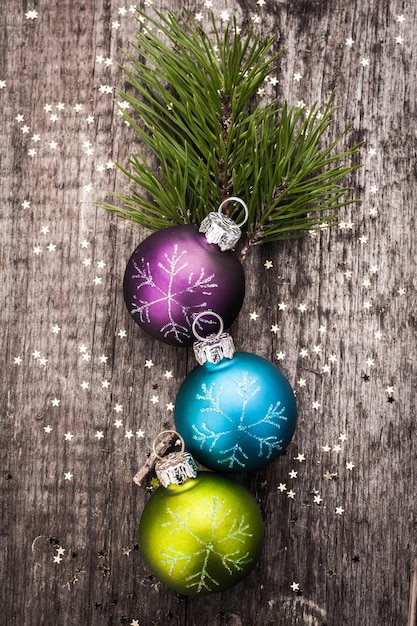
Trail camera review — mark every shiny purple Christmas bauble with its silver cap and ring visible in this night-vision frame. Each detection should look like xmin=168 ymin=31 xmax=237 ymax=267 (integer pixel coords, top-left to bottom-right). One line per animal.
xmin=123 ymin=198 xmax=247 ymax=347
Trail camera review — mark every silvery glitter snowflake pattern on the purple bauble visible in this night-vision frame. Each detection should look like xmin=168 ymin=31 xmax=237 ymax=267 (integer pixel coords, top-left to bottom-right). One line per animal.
xmin=131 ymin=244 xmax=218 ymax=343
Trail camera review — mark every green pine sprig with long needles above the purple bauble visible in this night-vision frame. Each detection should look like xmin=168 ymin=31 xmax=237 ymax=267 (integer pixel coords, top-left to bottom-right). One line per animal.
xmin=99 ymin=11 xmax=360 ymax=248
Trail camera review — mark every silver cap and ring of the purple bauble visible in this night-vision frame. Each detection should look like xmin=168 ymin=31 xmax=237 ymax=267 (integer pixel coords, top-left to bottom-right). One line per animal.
xmin=199 ymin=197 xmax=248 ymax=252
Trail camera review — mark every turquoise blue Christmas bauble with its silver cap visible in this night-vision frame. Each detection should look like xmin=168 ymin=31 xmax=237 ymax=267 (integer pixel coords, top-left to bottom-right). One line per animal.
xmin=174 ymin=313 xmax=297 ymax=472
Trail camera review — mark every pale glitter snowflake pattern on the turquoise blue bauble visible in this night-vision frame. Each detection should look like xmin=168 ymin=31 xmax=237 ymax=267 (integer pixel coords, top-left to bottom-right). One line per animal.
xmin=193 ymin=372 xmax=287 ymax=469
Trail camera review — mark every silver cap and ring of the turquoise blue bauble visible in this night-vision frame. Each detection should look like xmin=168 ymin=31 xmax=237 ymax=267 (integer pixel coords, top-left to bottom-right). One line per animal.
xmin=192 ymin=311 xmax=236 ymax=365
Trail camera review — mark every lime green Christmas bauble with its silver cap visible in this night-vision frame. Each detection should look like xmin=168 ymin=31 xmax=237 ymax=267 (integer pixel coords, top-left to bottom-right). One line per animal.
xmin=139 ymin=433 xmax=264 ymax=596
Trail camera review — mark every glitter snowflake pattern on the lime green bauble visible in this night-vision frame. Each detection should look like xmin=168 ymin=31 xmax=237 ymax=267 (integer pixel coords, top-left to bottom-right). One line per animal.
xmin=161 ymin=496 xmax=253 ymax=593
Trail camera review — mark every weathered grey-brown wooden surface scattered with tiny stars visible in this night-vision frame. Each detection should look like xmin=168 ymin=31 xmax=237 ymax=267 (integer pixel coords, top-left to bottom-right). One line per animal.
xmin=0 ymin=0 xmax=417 ymax=626
